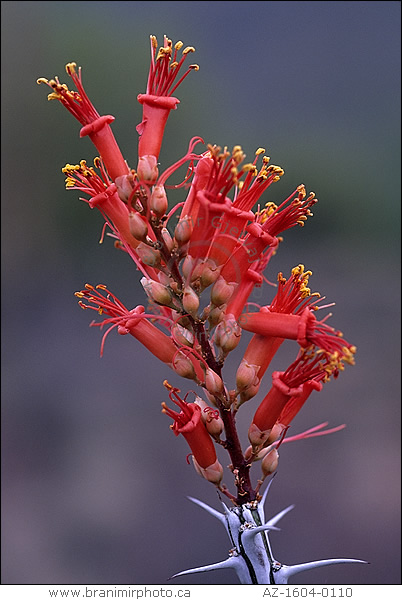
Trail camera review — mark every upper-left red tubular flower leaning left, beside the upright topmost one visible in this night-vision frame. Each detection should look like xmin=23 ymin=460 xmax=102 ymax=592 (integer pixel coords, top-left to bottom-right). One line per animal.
xmin=38 ymin=63 xmax=129 ymax=181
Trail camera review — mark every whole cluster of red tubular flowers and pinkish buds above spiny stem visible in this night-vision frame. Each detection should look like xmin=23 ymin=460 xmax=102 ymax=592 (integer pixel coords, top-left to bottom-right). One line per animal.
xmin=38 ymin=31 xmax=362 ymax=580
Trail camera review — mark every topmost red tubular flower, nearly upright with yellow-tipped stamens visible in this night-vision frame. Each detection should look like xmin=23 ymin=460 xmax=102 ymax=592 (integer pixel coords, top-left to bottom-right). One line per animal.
xmin=137 ymin=36 xmax=199 ymax=164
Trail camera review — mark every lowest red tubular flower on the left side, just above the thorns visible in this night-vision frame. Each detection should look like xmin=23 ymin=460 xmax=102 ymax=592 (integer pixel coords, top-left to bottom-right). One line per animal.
xmin=162 ymin=382 xmax=217 ymax=469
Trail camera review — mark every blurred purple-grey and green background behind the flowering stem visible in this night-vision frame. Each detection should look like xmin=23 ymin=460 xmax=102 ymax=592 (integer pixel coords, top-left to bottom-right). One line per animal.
xmin=1 ymin=2 xmax=401 ymax=586
